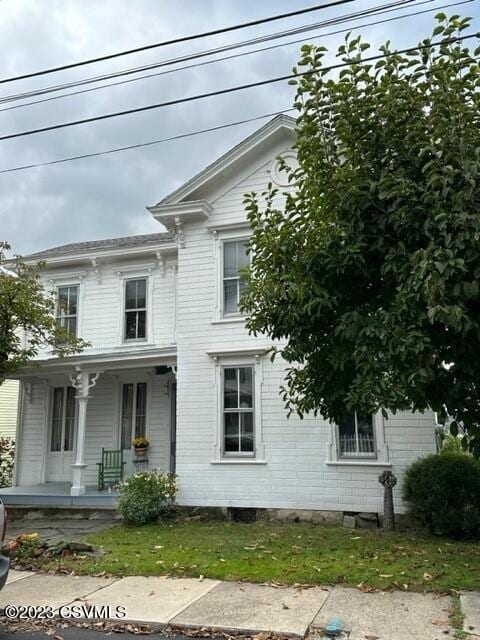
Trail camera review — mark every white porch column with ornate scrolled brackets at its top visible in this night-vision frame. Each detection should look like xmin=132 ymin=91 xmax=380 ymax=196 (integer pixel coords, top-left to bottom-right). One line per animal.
xmin=70 ymin=368 xmax=101 ymax=496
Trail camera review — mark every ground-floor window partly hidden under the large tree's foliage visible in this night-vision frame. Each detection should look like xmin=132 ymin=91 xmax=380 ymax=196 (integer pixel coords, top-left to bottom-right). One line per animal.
xmin=338 ymin=411 xmax=377 ymax=458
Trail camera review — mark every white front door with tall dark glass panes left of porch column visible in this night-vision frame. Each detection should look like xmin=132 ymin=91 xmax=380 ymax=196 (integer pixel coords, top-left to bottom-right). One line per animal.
xmin=46 ymin=387 xmax=76 ymax=482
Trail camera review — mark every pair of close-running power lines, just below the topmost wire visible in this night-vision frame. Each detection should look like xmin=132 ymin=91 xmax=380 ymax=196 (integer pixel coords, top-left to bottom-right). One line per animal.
xmin=0 ymin=0 xmax=464 ymax=112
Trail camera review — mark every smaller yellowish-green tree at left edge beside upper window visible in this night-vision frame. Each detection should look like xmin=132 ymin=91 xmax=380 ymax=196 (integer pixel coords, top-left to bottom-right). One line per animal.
xmin=0 ymin=243 xmax=87 ymax=384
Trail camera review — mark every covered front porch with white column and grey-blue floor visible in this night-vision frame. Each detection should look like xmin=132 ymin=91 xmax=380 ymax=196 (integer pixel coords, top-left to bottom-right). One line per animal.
xmin=10 ymin=348 xmax=176 ymax=506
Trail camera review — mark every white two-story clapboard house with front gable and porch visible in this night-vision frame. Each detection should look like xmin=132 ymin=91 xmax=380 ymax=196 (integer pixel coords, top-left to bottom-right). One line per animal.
xmin=2 ymin=116 xmax=435 ymax=512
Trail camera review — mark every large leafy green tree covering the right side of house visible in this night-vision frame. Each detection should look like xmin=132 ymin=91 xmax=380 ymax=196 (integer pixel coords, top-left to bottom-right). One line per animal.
xmin=243 ymin=14 xmax=480 ymax=455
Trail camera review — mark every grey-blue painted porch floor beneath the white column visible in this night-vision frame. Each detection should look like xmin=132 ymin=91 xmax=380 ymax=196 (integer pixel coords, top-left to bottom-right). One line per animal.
xmin=0 ymin=482 xmax=117 ymax=509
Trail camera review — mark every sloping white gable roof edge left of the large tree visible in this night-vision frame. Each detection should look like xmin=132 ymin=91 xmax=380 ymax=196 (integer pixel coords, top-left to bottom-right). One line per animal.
xmin=156 ymin=114 xmax=296 ymax=210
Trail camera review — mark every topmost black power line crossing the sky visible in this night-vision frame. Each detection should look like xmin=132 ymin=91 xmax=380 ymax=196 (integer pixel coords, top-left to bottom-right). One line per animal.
xmin=0 ymin=0 xmax=362 ymax=84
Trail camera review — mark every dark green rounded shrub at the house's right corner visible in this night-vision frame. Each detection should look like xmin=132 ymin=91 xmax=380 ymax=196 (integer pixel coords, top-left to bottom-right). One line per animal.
xmin=403 ymin=453 xmax=480 ymax=537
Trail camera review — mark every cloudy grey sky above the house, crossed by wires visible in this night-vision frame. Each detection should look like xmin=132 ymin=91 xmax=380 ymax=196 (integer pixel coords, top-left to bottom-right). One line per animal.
xmin=0 ymin=0 xmax=480 ymax=254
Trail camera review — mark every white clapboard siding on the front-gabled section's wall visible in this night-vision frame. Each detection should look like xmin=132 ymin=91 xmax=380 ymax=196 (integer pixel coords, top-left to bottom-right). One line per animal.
xmin=173 ymin=135 xmax=435 ymax=511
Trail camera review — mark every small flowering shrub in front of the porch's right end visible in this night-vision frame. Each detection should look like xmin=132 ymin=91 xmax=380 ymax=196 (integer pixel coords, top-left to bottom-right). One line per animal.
xmin=118 ymin=471 xmax=177 ymax=525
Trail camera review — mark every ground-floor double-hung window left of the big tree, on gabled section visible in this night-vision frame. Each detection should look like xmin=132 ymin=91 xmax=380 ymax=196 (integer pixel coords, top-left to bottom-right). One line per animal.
xmin=223 ymin=366 xmax=255 ymax=456
